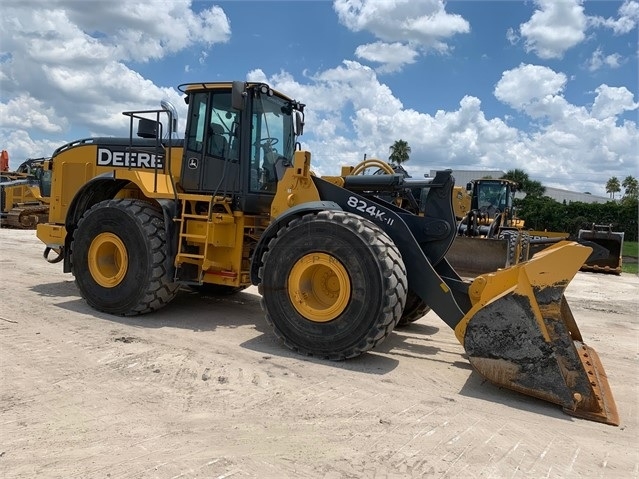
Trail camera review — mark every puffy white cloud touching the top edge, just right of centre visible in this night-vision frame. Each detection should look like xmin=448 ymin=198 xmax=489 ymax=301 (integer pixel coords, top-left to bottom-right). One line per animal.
xmin=333 ymin=0 xmax=470 ymax=72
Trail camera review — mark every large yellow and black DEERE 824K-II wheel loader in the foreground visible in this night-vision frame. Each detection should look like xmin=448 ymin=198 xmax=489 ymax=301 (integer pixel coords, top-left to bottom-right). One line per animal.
xmin=37 ymin=82 xmax=619 ymax=425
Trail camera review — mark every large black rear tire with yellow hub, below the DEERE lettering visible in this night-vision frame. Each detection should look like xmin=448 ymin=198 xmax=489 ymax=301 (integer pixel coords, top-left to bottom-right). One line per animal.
xmin=71 ymin=199 xmax=179 ymax=316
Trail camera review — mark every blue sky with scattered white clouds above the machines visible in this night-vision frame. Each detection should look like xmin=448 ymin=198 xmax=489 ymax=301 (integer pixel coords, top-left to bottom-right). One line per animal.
xmin=0 ymin=0 xmax=639 ymax=196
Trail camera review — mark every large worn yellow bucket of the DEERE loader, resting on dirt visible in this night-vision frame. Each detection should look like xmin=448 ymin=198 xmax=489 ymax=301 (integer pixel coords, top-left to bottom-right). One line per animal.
xmin=455 ymin=241 xmax=619 ymax=425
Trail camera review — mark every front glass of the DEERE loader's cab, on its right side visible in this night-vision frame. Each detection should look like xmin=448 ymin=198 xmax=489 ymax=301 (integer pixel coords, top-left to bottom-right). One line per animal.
xmin=250 ymin=95 xmax=295 ymax=191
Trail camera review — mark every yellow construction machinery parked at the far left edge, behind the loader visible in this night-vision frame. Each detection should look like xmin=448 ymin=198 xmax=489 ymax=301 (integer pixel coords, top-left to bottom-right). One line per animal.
xmin=0 ymin=150 xmax=49 ymax=229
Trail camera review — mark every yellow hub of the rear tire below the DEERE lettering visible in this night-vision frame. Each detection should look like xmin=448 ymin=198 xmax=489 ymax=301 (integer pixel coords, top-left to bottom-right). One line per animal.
xmin=89 ymin=233 xmax=129 ymax=288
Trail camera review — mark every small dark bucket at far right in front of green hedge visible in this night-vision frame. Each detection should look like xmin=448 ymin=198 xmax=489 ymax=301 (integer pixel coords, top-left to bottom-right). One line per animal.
xmin=578 ymin=225 xmax=624 ymax=274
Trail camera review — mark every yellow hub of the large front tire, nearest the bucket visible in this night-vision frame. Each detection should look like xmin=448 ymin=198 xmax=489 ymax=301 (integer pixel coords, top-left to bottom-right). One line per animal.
xmin=288 ymin=253 xmax=351 ymax=323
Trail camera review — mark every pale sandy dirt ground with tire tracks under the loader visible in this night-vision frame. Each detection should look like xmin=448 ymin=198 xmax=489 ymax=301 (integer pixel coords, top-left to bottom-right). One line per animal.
xmin=0 ymin=229 xmax=639 ymax=479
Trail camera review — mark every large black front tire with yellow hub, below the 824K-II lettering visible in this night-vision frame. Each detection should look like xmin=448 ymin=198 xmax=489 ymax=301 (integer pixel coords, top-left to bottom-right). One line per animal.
xmin=259 ymin=211 xmax=407 ymax=360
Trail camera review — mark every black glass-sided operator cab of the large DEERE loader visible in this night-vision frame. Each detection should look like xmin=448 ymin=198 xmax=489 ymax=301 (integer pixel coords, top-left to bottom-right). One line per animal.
xmin=180 ymin=82 xmax=304 ymax=213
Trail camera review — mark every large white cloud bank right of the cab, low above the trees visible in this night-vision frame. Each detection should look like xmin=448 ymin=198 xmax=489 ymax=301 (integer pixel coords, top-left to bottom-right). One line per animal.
xmin=258 ymin=62 xmax=639 ymax=194
